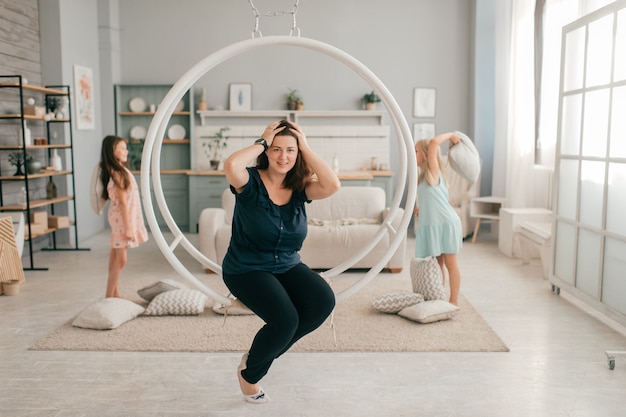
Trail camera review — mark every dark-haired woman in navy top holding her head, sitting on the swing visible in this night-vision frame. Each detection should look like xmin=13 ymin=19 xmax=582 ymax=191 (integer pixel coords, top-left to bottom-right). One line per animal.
xmin=222 ymin=120 xmax=341 ymax=403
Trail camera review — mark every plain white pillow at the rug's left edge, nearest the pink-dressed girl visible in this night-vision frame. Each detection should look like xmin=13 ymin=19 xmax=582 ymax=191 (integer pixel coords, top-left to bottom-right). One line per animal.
xmin=72 ymin=297 xmax=145 ymax=330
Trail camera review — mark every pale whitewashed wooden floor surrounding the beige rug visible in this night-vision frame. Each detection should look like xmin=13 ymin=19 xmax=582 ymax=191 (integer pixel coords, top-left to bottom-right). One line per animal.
xmin=0 ymin=233 xmax=626 ymax=417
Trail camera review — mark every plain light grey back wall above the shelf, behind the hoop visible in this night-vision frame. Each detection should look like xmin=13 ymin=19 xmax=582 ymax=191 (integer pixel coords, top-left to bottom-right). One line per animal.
xmin=111 ymin=0 xmax=473 ymax=184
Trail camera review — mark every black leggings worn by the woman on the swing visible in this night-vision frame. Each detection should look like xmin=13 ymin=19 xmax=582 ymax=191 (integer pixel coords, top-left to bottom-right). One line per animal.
xmin=224 ymin=264 xmax=335 ymax=384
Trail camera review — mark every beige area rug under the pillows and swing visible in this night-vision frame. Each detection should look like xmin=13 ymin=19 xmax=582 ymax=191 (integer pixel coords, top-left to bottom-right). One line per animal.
xmin=31 ymin=274 xmax=509 ymax=352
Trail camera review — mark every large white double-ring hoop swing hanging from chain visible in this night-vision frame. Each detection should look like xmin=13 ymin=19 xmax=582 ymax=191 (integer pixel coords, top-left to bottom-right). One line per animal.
xmin=141 ymin=36 xmax=417 ymax=305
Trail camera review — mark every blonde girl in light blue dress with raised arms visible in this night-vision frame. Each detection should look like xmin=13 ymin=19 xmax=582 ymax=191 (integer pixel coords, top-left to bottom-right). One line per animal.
xmin=415 ymin=133 xmax=463 ymax=305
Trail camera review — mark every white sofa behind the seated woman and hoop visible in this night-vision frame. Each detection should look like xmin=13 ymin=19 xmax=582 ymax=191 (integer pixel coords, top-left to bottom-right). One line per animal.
xmin=198 ymin=186 xmax=406 ymax=272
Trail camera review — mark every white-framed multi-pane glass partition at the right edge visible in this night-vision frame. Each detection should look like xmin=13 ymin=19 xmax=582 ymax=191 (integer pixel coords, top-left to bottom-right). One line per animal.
xmin=551 ymin=0 xmax=626 ymax=324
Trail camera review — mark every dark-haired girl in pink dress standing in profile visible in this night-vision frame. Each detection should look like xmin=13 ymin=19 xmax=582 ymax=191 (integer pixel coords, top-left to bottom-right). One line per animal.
xmin=100 ymin=135 xmax=148 ymax=298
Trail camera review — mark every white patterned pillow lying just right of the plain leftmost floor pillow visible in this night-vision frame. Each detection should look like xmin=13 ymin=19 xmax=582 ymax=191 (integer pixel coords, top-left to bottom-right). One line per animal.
xmin=144 ymin=289 xmax=208 ymax=316
